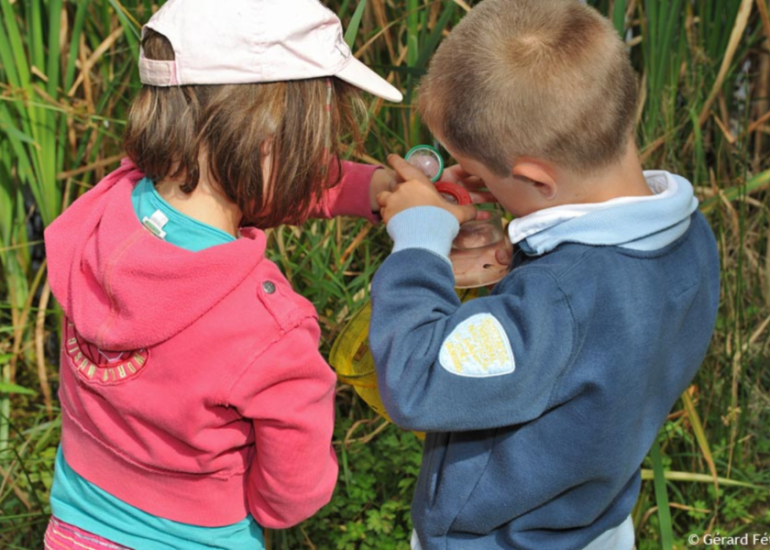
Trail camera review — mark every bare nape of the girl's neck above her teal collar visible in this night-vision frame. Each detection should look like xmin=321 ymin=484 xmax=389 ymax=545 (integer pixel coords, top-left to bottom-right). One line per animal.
xmin=155 ymin=168 xmax=243 ymax=237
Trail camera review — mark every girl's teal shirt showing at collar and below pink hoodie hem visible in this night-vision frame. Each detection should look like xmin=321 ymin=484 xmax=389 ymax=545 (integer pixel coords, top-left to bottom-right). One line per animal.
xmin=51 ymin=178 xmax=265 ymax=550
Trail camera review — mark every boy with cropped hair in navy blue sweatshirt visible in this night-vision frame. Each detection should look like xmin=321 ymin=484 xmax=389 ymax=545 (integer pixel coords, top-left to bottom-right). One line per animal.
xmin=370 ymin=0 xmax=719 ymax=550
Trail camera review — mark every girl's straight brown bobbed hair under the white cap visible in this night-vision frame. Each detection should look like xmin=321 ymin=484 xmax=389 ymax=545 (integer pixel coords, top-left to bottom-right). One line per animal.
xmin=124 ymin=29 xmax=365 ymax=228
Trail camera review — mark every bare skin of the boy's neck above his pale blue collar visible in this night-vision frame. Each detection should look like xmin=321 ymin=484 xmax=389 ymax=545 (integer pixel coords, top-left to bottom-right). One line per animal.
xmin=559 ymin=140 xmax=653 ymax=204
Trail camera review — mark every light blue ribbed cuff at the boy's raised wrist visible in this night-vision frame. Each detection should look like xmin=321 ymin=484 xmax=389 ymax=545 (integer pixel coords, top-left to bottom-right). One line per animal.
xmin=388 ymin=206 xmax=460 ymax=263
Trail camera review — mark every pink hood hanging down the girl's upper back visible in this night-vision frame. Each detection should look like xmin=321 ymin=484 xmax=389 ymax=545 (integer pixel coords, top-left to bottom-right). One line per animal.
xmin=45 ymin=159 xmax=265 ymax=350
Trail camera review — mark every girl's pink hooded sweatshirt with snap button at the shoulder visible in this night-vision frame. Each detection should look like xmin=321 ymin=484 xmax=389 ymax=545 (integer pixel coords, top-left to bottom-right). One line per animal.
xmin=46 ymin=160 xmax=376 ymax=528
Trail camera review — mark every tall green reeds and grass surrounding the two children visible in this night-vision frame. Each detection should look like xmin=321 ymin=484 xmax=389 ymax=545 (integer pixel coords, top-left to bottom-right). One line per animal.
xmin=0 ymin=0 xmax=770 ymax=550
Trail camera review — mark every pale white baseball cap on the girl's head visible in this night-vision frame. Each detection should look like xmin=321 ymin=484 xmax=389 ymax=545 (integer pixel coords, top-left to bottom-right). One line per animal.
xmin=139 ymin=0 xmax=403 ymax=102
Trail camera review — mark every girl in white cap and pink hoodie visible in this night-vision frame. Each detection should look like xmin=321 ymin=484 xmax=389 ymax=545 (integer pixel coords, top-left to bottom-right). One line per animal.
xmin=45 ymin=0 xmax=401 ymax=550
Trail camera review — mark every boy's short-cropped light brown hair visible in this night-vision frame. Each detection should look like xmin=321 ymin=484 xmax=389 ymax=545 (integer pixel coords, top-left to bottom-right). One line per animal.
xmin=419 ymin=0 xmax=638 ymax=176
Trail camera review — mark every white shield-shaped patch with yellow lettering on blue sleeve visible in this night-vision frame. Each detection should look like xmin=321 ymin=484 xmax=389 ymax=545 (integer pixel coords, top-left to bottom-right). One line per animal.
xmin=439 ymin=313 xmax=516 ymax=378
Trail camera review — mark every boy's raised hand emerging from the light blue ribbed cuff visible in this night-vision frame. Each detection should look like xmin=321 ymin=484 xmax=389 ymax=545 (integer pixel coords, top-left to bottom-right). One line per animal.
xmin=377 ymin=155 xmax=476 ymax=224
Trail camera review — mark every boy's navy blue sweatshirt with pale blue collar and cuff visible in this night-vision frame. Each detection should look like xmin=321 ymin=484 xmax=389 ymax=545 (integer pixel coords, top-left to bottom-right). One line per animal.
xmin=370 ymin=172 xmax=719 ymax=550
